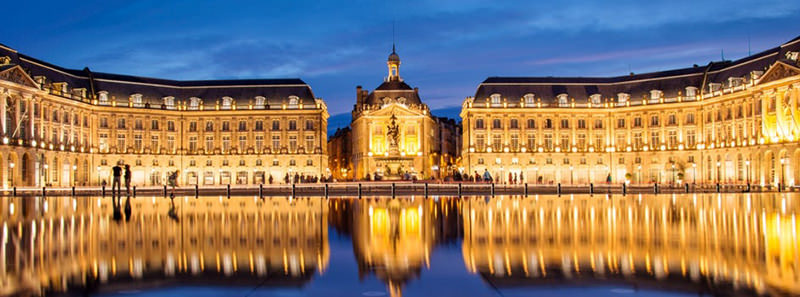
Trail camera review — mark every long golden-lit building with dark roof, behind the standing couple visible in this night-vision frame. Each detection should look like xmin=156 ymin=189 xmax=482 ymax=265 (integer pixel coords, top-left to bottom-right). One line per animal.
xmin=0 ymin=42 xmax=328 ymax=187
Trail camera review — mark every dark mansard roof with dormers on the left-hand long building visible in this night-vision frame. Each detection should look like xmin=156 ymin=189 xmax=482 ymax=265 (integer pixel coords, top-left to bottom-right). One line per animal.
xmin=0 ymin=45 xmax=315 ymax=105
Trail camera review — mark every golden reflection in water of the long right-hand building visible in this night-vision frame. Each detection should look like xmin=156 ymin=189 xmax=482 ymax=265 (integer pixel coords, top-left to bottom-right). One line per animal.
xmin=461 ymin=194 xmax=800 ymax=294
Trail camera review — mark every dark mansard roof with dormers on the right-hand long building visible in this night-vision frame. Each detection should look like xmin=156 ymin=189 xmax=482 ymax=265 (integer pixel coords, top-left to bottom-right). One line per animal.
xmin=475 ymin=37 xmax=800 ymax=103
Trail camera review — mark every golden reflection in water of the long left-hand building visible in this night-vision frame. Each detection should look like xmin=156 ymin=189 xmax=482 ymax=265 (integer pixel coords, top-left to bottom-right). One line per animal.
xmin=0 ymin=197 xmax=329 ymax=295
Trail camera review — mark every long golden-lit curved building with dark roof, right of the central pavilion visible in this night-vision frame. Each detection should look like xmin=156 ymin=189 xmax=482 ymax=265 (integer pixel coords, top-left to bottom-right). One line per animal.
xmin=461 ymin=38 xmax=800 ymax=186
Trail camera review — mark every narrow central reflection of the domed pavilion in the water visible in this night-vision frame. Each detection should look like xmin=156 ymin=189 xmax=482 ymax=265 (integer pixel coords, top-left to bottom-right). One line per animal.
xmin=331 ymin=198 xmax=461 ymax=296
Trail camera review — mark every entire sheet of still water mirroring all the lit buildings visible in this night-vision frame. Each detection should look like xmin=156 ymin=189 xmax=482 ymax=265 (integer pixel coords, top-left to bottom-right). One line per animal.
xmin=0 ymin=193 xmax=800 ymax=296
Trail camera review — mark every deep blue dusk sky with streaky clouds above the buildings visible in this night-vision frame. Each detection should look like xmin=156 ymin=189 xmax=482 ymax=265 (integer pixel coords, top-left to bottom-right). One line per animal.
xmin=0 ymin=0 xmax=800 ymax=128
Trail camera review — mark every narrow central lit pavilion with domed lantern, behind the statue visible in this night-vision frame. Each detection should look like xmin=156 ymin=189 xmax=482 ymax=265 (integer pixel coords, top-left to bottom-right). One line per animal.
xmin=350 ymin=49 xmax=450 ymax=179
